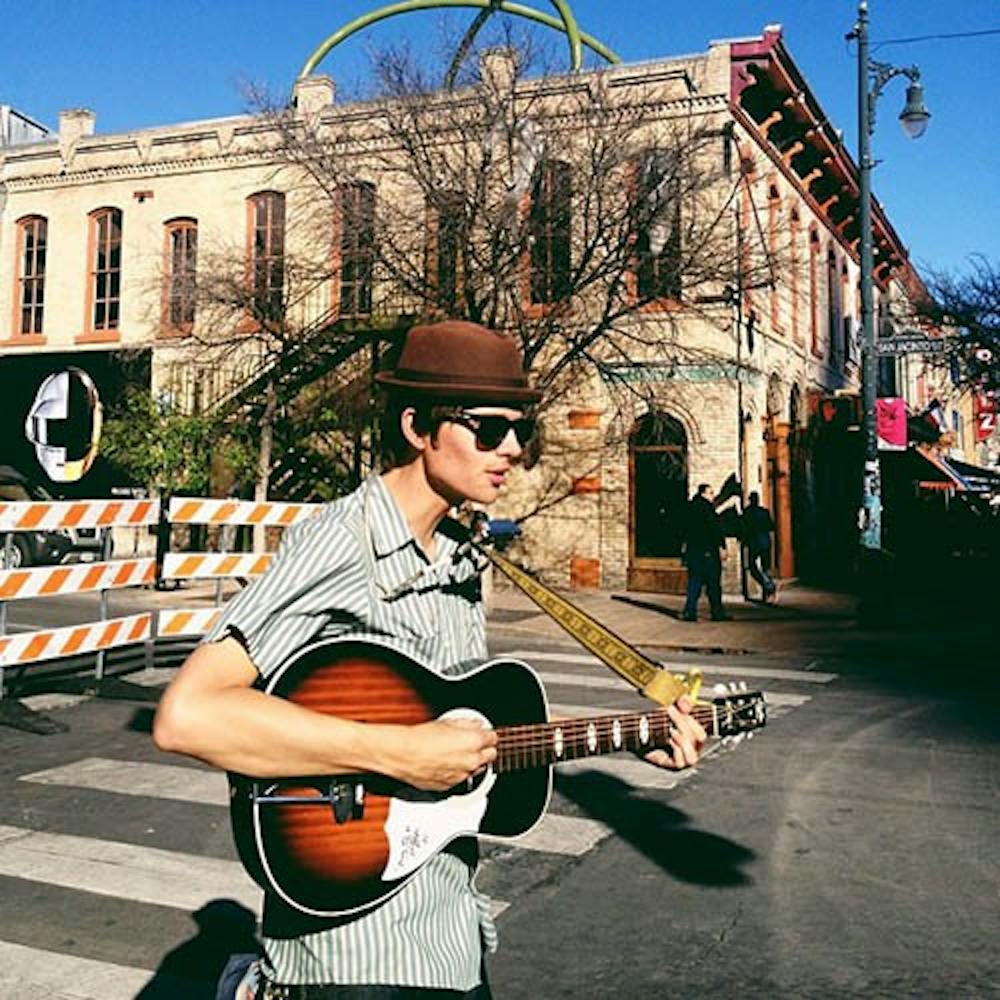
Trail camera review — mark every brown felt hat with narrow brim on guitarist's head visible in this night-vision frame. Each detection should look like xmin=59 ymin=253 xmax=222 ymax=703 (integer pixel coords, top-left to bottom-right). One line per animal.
xmin=375 ymin=320 xmax=542 ymax=404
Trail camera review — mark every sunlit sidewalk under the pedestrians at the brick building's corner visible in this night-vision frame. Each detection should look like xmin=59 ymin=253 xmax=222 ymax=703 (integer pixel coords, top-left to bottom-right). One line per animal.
xmin=488 ymin=581 xmax=990 ymax=663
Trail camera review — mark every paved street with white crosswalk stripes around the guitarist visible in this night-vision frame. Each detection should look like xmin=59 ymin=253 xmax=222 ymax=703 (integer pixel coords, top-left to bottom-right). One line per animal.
xmin=0 ymin=595 xmax=1000 ymax=1000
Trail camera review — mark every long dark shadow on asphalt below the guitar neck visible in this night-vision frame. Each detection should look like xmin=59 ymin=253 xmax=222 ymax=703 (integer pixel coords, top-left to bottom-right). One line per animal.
xmin=555 ymin=765 xmax=756 ymax=888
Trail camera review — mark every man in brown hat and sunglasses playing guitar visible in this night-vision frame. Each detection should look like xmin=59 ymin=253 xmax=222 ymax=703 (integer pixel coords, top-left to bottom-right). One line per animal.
xmin=153 ymin=321 xmax=705 ymax=1000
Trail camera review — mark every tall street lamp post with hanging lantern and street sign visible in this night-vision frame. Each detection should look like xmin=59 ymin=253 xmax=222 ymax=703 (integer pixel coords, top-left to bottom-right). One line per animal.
xmin=847 ymin=0 xmax=930 ymax=555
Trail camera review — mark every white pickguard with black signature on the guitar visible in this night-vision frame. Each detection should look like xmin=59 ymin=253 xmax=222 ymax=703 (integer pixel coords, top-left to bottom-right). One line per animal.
xmin=382 ymin=708 xmax=497 ymax=882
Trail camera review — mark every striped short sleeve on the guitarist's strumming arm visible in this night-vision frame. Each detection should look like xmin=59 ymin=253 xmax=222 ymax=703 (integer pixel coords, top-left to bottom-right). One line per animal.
xmin=205 ymin=514 xmax=368 ymax=677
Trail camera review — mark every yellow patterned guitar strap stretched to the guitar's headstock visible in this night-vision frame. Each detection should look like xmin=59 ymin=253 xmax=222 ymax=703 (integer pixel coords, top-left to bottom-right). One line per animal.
xmin=477 ymin=546 xmax=701 ymax=705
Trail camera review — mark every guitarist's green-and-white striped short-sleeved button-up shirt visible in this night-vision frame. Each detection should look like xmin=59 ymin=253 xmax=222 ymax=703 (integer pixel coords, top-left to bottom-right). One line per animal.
xmin=206 ymin=476 xmax=496 ymax=990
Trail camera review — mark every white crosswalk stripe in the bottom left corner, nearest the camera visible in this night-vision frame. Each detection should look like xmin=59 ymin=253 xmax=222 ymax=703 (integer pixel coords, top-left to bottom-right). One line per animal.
xmin=0 ymin=941 xmax=160 ymax=1000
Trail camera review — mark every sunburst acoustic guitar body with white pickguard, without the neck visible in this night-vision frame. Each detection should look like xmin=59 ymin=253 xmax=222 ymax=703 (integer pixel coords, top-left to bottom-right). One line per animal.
xmin=230 ymin=640 xmax=552 ymax=917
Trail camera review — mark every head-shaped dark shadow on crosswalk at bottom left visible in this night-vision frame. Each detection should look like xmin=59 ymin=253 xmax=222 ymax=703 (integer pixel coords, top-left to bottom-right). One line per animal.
xmin=136 ymin=899 xmax=260 ymax=1000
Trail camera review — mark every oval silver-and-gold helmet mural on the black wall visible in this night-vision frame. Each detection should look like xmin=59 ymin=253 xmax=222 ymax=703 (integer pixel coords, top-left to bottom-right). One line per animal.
xmin=24 ymin=366 xmax=104 ymax=483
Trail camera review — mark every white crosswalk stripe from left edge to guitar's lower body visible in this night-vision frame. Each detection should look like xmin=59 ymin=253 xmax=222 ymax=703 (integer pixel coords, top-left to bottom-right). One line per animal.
xmin=0 ymin=826 xmax=261 ymax=913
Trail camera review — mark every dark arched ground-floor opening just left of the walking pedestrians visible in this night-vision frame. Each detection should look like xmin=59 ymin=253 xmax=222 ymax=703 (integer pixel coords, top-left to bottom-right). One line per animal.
xmin=629 ymin=412 xmax=688 ymax=559
